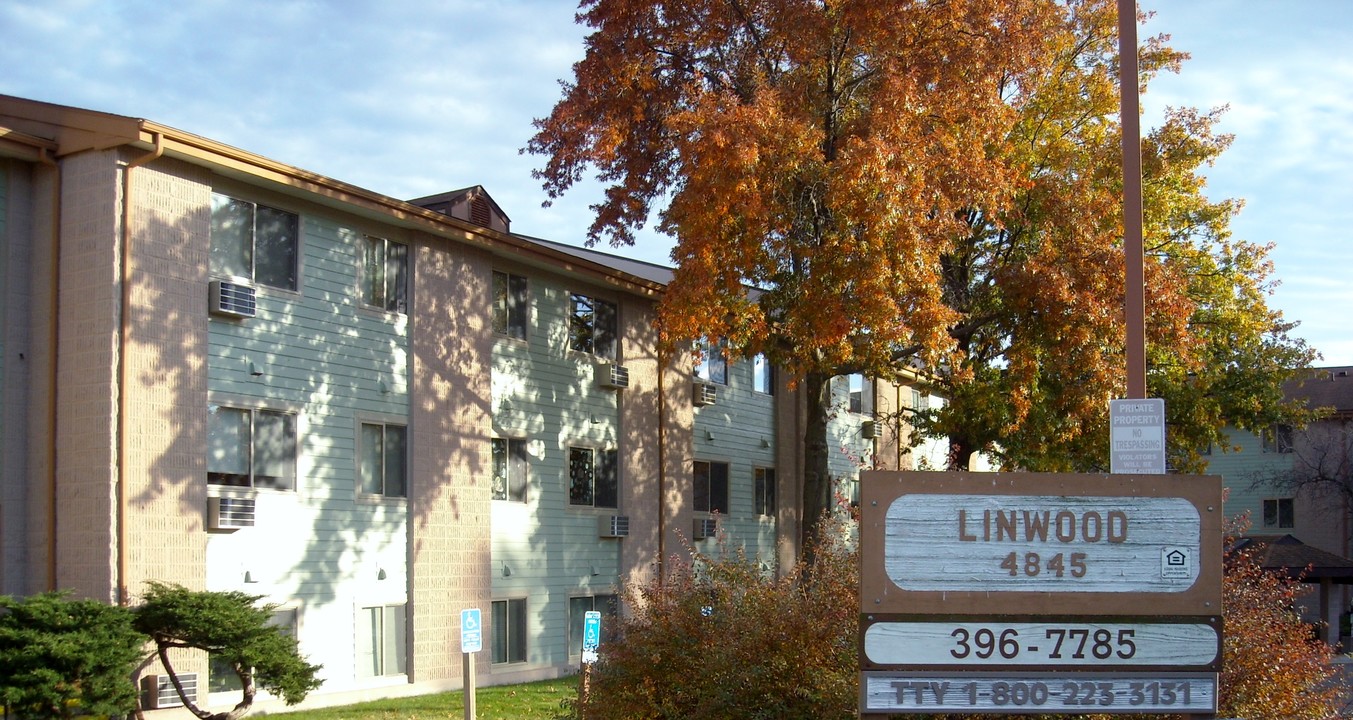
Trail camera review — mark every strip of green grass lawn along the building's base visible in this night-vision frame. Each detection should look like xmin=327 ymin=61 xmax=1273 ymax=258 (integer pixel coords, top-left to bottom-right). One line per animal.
xmin=263 ymin=675 xmax=578 ymax=720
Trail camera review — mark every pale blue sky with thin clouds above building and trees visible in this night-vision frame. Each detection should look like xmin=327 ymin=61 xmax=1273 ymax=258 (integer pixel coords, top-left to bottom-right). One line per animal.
xmin=0 ymin=0 xmax=1353 ymax=365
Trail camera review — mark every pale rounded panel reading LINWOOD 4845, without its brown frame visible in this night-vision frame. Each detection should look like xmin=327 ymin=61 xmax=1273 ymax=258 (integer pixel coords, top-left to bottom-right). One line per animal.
xmin=884 ymin=493 xmax=1201 ymax=593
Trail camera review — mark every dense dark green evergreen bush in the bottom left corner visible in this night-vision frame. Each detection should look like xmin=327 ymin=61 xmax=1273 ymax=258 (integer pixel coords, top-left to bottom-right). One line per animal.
xmin=0 ymin=593 xmax=146 ymax=717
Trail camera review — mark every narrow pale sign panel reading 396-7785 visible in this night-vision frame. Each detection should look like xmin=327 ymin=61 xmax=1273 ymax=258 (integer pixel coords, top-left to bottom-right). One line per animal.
xmin=865 ymin=620 xmax=1220 ymax=670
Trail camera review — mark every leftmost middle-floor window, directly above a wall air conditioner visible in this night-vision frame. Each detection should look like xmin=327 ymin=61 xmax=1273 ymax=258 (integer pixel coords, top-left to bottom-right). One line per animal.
xmin=207 ymin=405 xmax=296 ymax=490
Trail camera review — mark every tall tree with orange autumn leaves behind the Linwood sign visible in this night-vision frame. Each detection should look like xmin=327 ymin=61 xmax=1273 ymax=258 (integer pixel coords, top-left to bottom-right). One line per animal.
xmin=528 ymin=0 xmax=1300 ymax=549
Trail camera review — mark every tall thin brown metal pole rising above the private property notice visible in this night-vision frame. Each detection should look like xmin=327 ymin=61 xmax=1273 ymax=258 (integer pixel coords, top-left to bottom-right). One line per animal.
xmin=1118 ymin=0 xmax=1146 ymax=399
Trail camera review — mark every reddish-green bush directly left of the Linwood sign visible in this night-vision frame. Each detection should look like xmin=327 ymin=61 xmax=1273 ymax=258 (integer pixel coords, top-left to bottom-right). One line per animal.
xmin=574 ymin=516 xmax=859 ymax=720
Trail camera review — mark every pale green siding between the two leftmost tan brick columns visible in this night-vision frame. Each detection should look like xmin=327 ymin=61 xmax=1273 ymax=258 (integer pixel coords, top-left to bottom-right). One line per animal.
xmin=203 ymin=194 xmax=418 ymax=686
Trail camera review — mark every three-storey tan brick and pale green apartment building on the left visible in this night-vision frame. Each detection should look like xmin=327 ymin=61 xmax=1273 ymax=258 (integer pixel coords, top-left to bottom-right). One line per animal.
xmin=0 ymin=96 xmax=920 ymax=712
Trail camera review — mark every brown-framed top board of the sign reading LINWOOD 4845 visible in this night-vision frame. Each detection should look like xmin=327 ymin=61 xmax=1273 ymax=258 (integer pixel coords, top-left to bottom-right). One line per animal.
xmin=861 ymin=471 xmax=1223 ymax=616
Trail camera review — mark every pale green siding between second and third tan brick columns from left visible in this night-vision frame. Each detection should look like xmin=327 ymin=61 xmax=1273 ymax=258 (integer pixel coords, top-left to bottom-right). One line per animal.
xmin=484 ymin=265 xmax=627 ymax=674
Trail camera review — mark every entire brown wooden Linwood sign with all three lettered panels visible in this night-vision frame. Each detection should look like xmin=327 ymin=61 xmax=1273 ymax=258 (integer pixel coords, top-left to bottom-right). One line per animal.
xmin=861 ymin=471 xmax=1223 ymax=715
